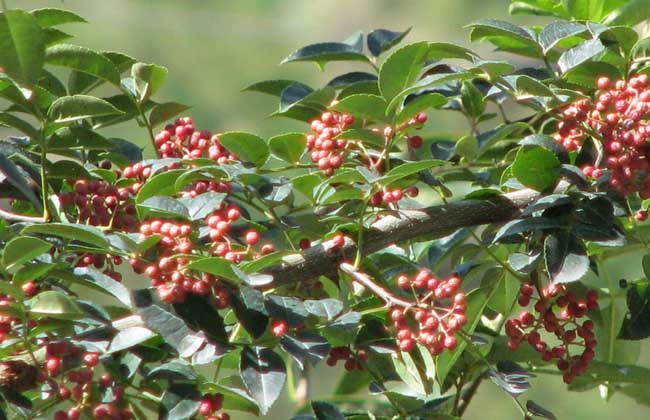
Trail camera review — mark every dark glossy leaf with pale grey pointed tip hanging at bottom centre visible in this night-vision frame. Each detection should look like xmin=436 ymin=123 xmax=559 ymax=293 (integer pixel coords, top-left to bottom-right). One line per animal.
xmin=239 ymin=346 xmax=287 ymax=415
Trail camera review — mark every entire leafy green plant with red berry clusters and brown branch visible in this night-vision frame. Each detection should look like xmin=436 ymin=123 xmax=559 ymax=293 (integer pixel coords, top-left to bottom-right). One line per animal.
xmin=0 ymin=0 xmax=650 ymax=420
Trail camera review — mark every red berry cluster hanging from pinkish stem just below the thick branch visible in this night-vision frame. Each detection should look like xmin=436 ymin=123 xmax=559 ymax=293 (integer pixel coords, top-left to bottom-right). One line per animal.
xmin=390 ymin=269 xmax=467 ymax=356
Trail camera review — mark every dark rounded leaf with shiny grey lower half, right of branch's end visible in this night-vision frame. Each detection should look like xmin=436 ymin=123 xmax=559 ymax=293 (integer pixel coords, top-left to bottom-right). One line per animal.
xmin=544 ymin=232 xmax=589 ymax=283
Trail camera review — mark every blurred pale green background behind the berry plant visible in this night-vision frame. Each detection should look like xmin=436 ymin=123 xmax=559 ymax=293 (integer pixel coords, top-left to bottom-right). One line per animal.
xmin=6 ymin=0 xmax=650 ymax=420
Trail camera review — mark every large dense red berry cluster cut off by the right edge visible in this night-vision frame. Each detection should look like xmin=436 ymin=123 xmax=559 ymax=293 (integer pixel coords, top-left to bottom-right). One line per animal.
xmin=555 ymin=74 xmax=650 ymax=199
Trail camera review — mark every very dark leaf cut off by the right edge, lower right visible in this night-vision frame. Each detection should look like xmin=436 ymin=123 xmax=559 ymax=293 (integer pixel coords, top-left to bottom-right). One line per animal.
xmin=618 ymin=281 xmax=650 ymax=340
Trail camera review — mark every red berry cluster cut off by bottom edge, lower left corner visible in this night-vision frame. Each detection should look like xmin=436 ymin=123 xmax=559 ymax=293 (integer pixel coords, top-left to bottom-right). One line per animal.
xmin=43 ymin=342 xmax=134 ymax=420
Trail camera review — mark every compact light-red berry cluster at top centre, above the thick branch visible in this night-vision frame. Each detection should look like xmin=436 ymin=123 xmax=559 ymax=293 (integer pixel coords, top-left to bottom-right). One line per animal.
xmin=307 ymin=106 xmax=354 ymax=176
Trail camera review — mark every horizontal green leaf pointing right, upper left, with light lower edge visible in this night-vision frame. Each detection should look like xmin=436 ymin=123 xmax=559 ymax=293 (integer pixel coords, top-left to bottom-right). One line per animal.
xmin=47 ymin=95 xmax=123 ymax=123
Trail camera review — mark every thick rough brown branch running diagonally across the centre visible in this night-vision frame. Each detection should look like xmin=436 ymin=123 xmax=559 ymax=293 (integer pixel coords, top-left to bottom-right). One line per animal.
xmin=264 ymin=183 xmax=548 ymax=288
